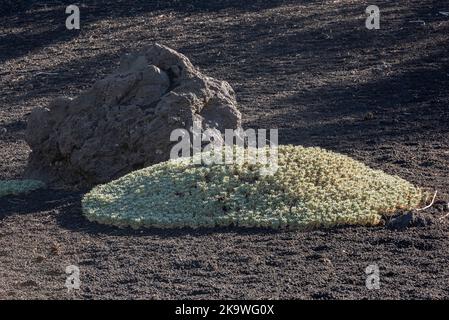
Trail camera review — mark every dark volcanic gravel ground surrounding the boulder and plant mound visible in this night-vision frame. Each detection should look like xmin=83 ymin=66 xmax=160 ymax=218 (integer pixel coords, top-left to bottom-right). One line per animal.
xmin=0 ymin=0 xmax=449 ymax=299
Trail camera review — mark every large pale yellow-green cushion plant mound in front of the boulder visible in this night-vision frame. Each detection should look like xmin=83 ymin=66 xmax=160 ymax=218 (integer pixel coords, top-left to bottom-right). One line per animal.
xmin=82 ymin=145 xmax=423 ymax=229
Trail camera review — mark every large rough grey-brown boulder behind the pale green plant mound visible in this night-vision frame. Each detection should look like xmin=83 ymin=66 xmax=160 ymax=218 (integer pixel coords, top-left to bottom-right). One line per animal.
xmin=26 ymin=44 xmax=241 ymax=186
